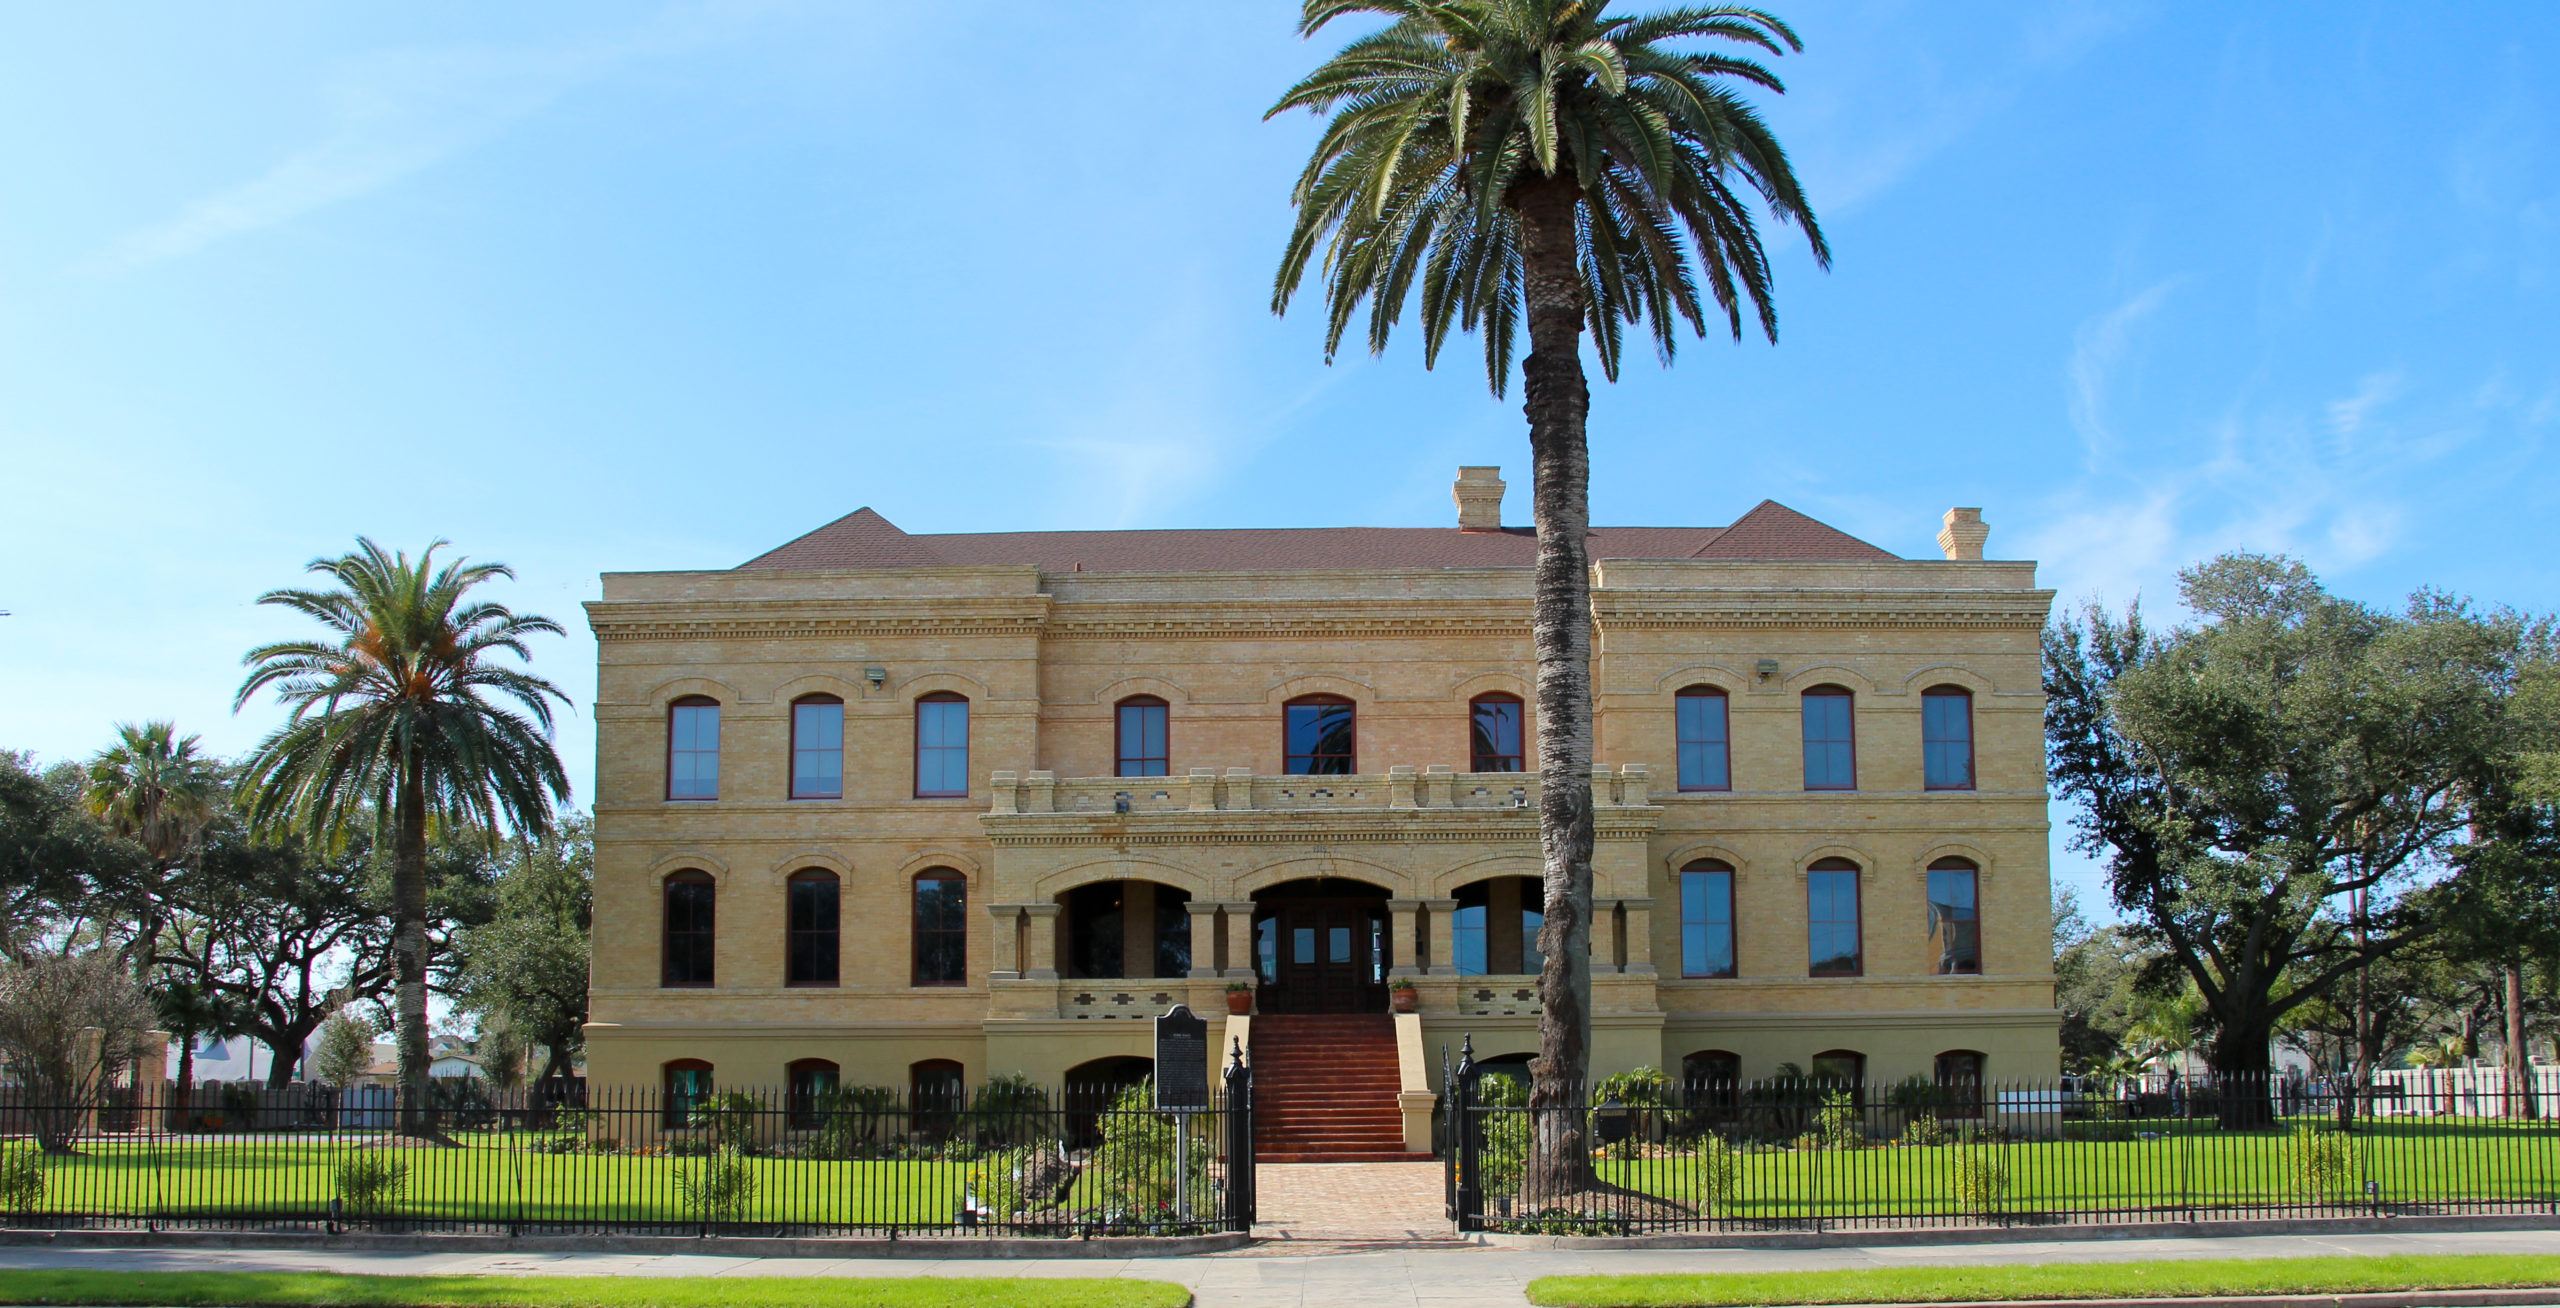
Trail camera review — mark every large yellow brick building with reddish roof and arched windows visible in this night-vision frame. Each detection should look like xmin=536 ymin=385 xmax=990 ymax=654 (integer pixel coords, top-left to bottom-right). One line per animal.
xmin=589 ymin=468 xmax=2056 ymax=1147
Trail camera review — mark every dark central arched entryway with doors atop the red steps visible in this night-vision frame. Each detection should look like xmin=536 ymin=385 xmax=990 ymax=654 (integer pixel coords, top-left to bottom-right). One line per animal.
xmin=1254 ymin=875 xmax=1395 ymax=1014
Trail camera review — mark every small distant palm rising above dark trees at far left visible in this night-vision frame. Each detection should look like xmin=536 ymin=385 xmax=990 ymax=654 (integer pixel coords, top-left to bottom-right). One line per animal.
xmin=82 ymin=722 xmax=223 ymax=970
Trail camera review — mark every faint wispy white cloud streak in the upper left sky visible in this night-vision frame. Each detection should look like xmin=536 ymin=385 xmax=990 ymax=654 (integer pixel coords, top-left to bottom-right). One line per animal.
xmin=87 ymin=15 xmax=694 ymax=271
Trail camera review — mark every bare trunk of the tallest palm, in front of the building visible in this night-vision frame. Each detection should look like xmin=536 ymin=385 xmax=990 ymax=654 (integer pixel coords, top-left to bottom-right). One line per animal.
xmin=1518 ymin=174 xmax=1592 ymax=1211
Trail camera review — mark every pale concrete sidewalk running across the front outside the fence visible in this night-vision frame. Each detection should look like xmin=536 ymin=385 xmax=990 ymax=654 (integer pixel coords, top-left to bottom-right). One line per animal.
xmin=0 ymin=1231 xmax=2560 ymax=1308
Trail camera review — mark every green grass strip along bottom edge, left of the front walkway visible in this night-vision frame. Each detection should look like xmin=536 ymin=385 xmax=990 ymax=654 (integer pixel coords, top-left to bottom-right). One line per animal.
xmin=0 ymin=1270 xmax=1190 ymax=1308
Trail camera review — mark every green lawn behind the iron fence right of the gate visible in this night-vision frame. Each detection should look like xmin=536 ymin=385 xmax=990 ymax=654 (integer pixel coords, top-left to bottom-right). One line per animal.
xmin=1556 ymin=1119 xmax=2560 ymax=1218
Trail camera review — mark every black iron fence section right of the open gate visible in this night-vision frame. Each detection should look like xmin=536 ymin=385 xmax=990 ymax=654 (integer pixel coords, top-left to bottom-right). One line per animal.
xmin=1441 ymin=1039 xmax=2560 ymax=1234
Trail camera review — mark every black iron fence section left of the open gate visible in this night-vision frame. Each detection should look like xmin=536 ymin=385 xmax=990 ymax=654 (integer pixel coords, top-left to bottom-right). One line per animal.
xmin=0 ymin=1065 xmax=1254 ymax=1239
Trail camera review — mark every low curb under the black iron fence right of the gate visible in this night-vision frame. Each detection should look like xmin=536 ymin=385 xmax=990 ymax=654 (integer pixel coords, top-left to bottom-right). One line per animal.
xmin=1477 ymin=1213 xmax=2560 ymax=1254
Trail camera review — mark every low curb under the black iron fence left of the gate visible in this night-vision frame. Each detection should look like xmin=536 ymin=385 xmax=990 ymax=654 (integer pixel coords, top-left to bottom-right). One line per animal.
xmin=0 ymin=1231 xmax=1254 ymax=1259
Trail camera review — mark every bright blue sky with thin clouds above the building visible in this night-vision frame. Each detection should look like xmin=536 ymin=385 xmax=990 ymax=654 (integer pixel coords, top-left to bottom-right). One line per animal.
xmin=0 ymin=0 xmax=2560 ymax=911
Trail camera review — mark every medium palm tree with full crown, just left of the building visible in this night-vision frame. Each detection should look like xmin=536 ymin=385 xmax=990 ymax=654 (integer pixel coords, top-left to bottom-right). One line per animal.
xmin=233 ymin=538 xmax=568 ymax=1134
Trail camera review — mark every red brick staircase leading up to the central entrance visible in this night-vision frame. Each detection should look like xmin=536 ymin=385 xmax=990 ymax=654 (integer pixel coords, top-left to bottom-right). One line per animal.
xmin=1252 ymin=1014 xmax=1431 ymax=1162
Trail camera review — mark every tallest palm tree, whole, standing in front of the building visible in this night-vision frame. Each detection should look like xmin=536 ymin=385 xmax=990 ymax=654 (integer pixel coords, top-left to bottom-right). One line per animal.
xmin=1272 ymin=0 xmax=1830 ymax=1198
